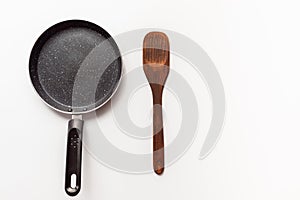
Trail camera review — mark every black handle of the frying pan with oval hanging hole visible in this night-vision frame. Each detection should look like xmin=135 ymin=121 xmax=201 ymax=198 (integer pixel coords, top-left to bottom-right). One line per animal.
xmin=65 ymin=119 xmax=83 ymax=196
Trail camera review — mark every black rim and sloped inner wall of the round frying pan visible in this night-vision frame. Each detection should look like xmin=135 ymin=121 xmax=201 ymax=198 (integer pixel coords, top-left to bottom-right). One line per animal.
xmin=28 ymin=19 xmax=123 ymax=115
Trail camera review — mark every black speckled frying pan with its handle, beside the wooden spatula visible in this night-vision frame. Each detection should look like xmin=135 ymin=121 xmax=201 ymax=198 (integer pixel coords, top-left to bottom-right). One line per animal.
xmin=29 ymin=20 xmax=122 ymax=196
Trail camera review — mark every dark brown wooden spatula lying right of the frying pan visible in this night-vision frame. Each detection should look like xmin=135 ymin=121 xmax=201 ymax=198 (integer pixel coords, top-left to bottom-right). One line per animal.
xmin=143 ymin=32 xmax=170 ymax=175
